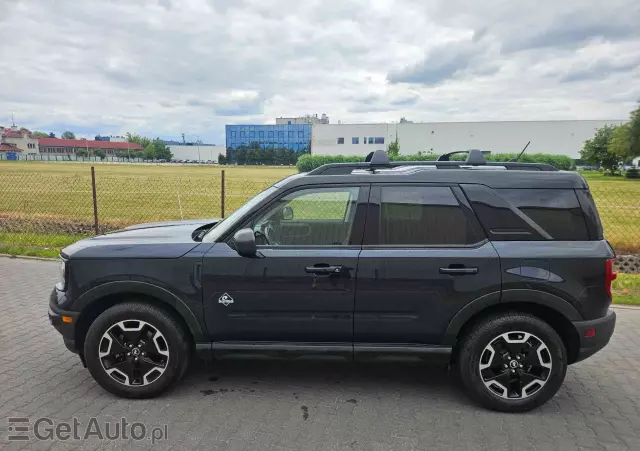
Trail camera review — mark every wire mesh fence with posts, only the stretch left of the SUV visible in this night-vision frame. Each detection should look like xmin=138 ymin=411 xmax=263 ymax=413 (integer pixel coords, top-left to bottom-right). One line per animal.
xmin=0 ymin=167 xmax=275 ymax=245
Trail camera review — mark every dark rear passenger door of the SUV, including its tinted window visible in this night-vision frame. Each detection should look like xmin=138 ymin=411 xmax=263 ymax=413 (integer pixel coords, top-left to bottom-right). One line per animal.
xmin=354 ymin=184 xmax=501 ymax=344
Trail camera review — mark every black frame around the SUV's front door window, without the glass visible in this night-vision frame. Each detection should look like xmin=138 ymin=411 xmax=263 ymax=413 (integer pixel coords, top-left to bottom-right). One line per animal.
xmin=228 ymin=183 xmax=371 ymax=250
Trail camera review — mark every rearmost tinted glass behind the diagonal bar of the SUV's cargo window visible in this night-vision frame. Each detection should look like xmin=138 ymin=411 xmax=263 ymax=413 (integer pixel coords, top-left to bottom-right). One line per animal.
xmin=496 ymin=189 xmax=589 ymax=241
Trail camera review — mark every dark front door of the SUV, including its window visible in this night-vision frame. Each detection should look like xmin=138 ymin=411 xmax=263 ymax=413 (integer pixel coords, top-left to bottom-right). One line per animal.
xmin=202 ymin=186 xmax=369 ymax=346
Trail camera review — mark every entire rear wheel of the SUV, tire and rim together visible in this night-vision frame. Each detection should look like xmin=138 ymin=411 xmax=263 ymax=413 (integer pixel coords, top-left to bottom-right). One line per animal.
xmin=458 ymin=313 xmax=567 ymax=412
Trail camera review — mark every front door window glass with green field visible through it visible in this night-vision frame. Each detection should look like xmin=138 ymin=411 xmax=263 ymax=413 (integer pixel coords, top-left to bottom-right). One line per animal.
xmin=251 ymin=187 xmax=360 ymax=246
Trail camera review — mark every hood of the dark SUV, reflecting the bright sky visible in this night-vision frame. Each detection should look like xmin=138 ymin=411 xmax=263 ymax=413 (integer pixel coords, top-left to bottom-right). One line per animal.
xmin=61 ymin=219 xmax=220 ymax=259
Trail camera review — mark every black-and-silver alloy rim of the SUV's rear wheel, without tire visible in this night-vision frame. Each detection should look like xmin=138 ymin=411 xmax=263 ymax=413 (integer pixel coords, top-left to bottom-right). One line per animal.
xmin=479 ymin=331 xmax=552 ymax=399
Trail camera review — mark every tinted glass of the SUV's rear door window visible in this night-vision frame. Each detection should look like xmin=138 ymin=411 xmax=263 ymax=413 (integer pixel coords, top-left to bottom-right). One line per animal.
xmin=380 ymin=186 xmax=478 ymax=246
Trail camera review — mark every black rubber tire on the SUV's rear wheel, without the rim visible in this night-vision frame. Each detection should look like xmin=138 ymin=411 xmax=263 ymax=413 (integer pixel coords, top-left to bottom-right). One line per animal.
xmin=457 ymin=312 xmax=567 ymax=412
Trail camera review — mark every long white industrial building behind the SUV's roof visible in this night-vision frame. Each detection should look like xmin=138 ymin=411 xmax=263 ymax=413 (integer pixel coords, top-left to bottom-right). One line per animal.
xmin=311 ymin=119 xmax=626 ymax=159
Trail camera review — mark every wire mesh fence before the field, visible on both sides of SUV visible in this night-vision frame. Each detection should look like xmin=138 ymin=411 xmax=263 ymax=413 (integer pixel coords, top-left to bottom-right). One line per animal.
xmin=0 ymin=166 xmax=640 ymax=253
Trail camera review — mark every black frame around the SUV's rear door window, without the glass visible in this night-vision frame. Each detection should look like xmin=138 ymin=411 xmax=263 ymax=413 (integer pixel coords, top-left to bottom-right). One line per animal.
xmin=362 ymin=183 xmax=489 ymax=249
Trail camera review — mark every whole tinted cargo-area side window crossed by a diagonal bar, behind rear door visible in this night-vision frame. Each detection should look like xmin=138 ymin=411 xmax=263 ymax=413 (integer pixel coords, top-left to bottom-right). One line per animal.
xmin=462 ymin=185 xmax=589 ymax=241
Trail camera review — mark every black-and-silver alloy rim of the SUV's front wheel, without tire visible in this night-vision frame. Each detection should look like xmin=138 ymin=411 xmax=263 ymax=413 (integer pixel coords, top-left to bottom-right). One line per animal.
xmin=98 ymin=320 xmax=169 ymax=386
